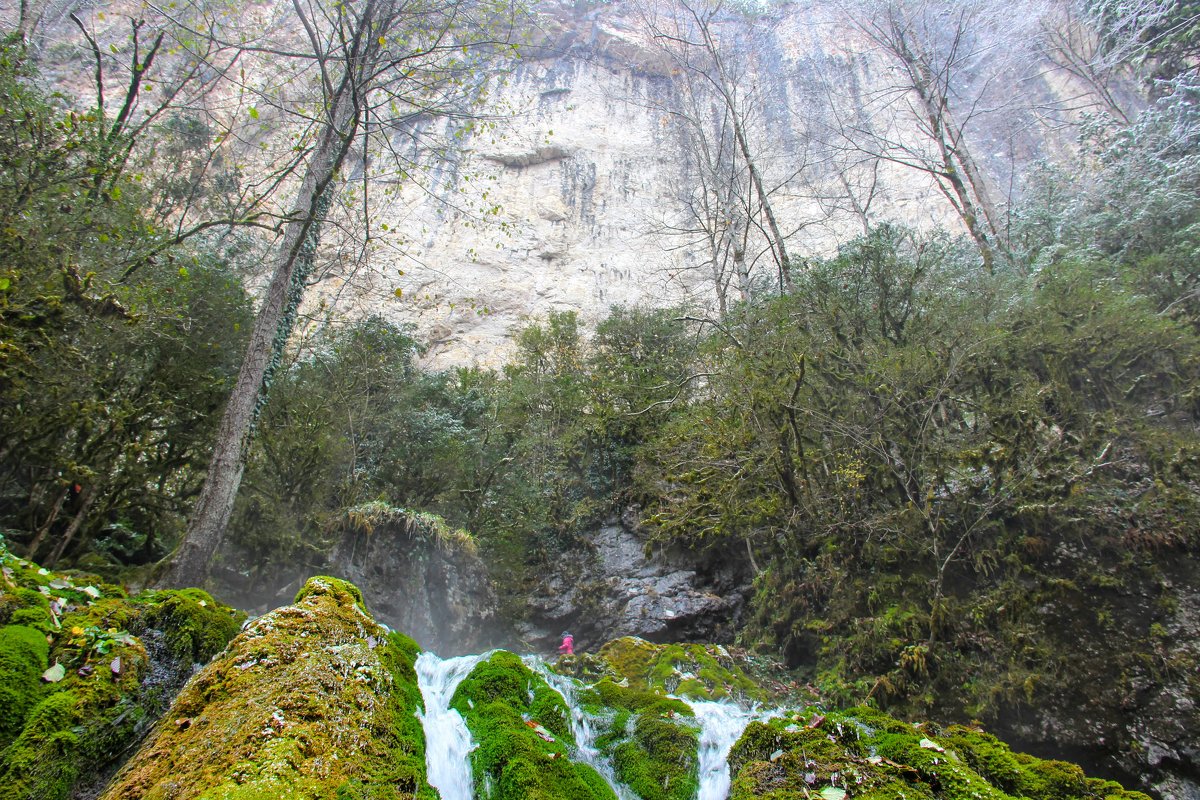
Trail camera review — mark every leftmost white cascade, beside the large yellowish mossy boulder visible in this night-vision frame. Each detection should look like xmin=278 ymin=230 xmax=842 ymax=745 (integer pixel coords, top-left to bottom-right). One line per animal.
xmin=416 ymin=651 xmax=491 ymax=800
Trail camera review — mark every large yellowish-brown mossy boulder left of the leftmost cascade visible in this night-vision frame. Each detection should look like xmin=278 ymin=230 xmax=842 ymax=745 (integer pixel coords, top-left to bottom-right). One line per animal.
xmin=102 ymin=577 xmax=436 ymax=800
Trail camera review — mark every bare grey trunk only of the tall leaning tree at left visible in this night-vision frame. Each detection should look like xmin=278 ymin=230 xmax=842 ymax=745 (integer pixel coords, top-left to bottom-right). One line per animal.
xmin=156 ymin=76 xmax=359 ymax=587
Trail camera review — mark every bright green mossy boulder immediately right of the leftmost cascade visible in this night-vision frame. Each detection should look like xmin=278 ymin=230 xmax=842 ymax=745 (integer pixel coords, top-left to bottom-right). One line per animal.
xmin=450 ymin=651 xmax=617 ymax=800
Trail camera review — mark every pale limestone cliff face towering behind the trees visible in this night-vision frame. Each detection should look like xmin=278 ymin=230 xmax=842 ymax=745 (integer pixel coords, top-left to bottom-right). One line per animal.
xmin=323 ymin=2 xmax=1118 ymax=366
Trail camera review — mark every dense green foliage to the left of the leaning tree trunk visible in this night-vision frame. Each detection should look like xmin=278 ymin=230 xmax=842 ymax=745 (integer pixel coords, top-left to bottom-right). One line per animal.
xmin=0 ymin=46 xmax=248 ymax=565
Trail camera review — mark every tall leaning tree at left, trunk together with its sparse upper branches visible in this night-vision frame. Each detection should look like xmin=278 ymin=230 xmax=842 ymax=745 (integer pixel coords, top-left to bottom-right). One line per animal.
xmin=158 ymin=0 xmax=515 ymax=585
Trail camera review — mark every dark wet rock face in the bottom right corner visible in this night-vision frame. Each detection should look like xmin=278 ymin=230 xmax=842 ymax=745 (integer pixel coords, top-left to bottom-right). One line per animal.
xmin=991 ymin=559 xmax=1200 ymax=800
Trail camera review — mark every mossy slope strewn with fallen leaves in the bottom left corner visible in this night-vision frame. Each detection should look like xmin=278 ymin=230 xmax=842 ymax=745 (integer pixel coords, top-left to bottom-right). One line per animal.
xmin=0 ymin=543 xmax=241 ymax=800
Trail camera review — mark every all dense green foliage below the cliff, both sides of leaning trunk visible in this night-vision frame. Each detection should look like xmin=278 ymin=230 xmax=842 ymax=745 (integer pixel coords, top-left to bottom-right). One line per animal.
xmin=0 ymin=17 xmax=1200 ymax=796
